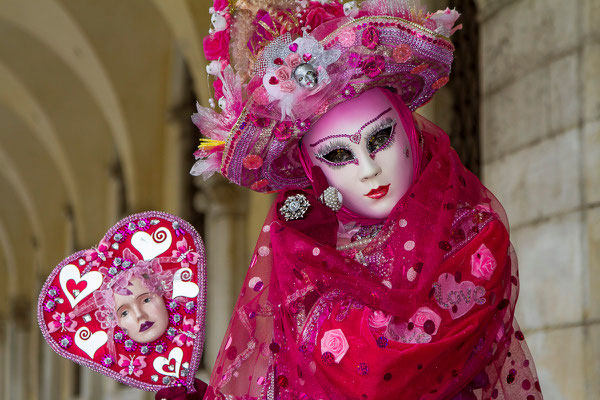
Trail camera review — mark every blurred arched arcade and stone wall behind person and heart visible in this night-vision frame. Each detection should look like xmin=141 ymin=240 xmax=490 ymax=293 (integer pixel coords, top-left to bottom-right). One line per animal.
xmin=0 ymin=0 xmax=600 ymax=400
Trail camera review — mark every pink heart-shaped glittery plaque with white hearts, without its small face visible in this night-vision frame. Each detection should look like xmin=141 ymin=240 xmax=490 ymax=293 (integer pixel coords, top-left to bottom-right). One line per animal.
xmin=37 ymin=211 xmax=206 ymax=391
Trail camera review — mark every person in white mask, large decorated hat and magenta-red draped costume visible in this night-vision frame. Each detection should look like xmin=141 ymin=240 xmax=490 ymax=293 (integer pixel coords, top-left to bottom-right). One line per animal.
xmin=192 ymin=0 xmax=542 ymax=400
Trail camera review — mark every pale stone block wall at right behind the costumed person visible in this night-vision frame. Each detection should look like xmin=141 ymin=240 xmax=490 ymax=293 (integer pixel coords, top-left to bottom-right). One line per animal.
xmin=476 ymin=0 xmax=600 ymax=400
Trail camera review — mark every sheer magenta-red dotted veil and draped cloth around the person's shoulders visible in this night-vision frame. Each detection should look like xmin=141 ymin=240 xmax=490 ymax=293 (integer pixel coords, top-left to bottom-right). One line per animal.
xmin=205 ymin=104 xmax=542 ymax=400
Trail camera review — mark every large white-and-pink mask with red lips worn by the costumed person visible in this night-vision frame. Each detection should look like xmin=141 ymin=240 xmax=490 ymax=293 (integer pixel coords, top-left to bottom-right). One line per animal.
xmin=302 ymin=88 xmax=413 ymax=219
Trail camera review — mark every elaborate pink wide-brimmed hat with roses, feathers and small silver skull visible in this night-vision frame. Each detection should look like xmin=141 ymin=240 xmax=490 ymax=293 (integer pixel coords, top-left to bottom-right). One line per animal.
xmin=191 ymin=0 xmax=459 ymax=192
